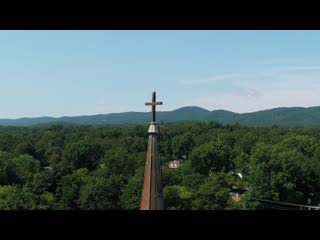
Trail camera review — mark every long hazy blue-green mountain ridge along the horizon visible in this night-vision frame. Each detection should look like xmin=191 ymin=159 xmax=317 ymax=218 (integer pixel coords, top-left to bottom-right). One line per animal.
xmin=0 ymin=107 xmax=320 ymax=127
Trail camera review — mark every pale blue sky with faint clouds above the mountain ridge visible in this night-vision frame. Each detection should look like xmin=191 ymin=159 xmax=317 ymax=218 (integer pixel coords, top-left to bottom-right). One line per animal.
xmin=0 ymin=31 xmax=320 ymax=118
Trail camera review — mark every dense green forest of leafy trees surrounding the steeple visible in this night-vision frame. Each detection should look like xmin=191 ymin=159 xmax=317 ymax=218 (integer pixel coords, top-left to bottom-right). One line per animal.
xmin=0 ymin=122 xmax=320 ymax=210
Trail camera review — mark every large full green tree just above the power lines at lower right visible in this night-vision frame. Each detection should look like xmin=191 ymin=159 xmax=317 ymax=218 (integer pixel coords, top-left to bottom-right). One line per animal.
xmin=248 ymin=143 xmax=305 ymax=203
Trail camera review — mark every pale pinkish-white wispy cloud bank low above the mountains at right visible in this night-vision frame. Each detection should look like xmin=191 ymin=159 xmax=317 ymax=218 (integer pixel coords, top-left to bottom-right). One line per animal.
xmin=186 ymin=65 xmax=320 ymax=113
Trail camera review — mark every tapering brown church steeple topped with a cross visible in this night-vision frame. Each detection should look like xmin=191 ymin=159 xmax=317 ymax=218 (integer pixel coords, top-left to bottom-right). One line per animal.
xmin=140 ymin=92 xmax=164 ymax=210
